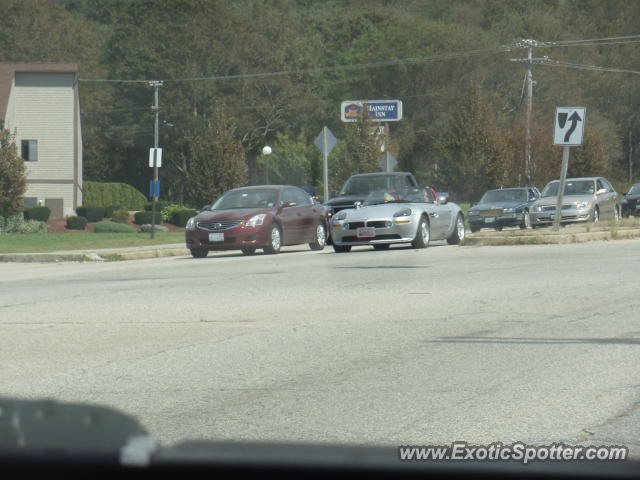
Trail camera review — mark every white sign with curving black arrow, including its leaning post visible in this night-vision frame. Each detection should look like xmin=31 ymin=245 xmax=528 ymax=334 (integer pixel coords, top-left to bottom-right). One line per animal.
xmin=553 ymin=107 xmax=587 ymax=231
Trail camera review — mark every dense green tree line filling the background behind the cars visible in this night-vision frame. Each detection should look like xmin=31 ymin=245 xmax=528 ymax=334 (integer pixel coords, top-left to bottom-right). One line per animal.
xmin=0 ymin=0 xmax=640 ymax=206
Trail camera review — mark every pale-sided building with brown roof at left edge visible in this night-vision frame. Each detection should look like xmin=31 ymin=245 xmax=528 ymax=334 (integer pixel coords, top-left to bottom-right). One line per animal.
xmin=0 ymin=63 xmax=82 ymax=218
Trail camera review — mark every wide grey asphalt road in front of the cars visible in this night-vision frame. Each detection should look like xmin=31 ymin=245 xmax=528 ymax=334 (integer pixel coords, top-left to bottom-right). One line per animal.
xmin=0 ymin=241 xmax=640 ymax=451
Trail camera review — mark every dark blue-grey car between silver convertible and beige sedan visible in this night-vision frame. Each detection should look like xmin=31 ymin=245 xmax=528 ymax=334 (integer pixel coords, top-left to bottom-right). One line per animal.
xmin=468 ymin=187 xmax=540 ymax=232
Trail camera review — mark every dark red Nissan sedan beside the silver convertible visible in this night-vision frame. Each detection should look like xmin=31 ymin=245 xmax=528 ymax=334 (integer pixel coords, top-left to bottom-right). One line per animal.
xmin=186 ymin=185 xmax=327 ymax=258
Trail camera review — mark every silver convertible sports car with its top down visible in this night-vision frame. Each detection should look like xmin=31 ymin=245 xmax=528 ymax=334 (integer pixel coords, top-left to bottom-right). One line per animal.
xmin=331 ymin=187 xmax=465 ymax=253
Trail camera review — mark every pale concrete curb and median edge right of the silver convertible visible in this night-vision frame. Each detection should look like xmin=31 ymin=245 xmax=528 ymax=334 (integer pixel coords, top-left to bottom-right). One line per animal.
xmin=464 ymin=228 xmax=640 ymax=246
